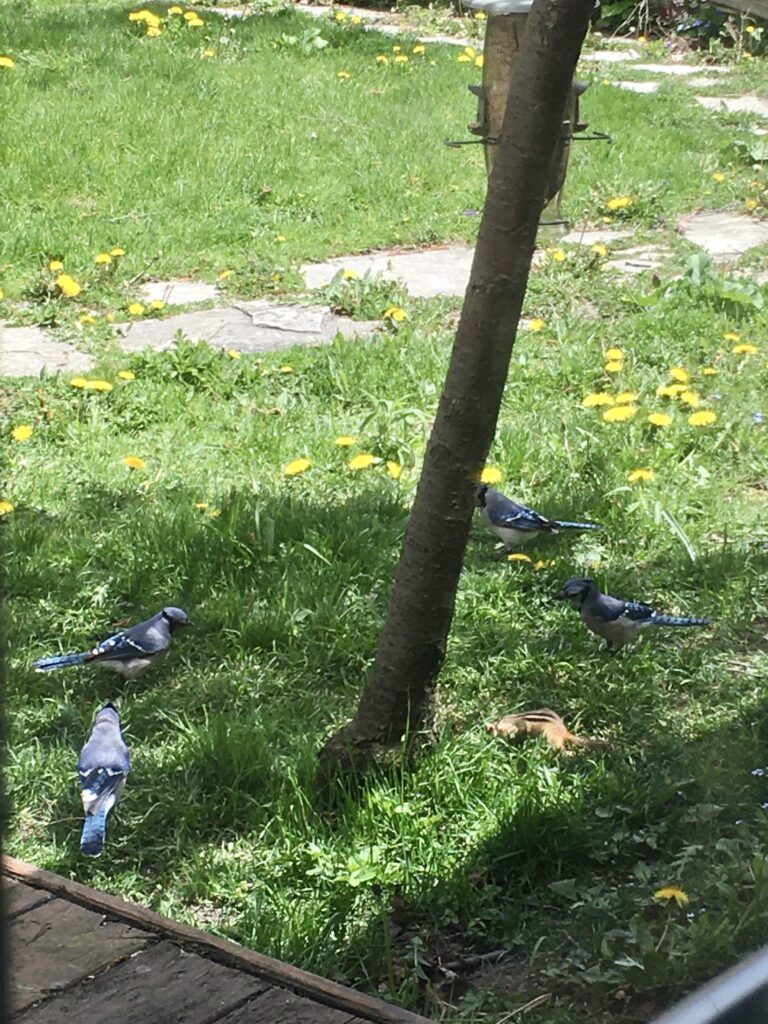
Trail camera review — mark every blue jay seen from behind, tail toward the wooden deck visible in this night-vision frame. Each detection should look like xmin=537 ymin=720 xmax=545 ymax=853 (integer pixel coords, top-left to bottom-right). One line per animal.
xmin=78 ymin=703 xmax=131 ymax=857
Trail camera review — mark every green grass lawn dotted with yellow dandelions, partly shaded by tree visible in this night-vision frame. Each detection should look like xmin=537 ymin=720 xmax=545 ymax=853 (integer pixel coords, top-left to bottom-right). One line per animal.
xmin=0 ymin=2 xmax=768 ymax=1024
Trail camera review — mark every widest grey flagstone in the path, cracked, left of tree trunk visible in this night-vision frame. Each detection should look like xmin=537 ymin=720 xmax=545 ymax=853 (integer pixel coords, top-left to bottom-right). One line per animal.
xmin=120 ymin=301 xmax=381 ymax=352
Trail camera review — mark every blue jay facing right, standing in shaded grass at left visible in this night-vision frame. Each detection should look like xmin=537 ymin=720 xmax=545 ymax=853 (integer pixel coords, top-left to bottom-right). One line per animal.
xmin=33 ymin=607 xmax=189 ymax=679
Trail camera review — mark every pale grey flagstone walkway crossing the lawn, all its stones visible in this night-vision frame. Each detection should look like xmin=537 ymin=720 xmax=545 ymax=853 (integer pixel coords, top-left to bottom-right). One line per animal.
xmin=0 ymin=4 xmax=768 ymax=377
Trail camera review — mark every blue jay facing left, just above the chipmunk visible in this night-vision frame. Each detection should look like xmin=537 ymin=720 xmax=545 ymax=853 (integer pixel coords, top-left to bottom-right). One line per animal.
xmin=555 ymin=579 xmax=710 ymax=650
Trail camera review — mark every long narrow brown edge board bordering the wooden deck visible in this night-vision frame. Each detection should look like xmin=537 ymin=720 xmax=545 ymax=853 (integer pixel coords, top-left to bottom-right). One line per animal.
xmin=2 ymin=856 xmax=434 ymax=1024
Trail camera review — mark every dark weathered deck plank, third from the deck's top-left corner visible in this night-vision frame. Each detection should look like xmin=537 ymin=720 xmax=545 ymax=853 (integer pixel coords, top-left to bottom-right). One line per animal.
xmin=18 ymin=942 xmax=270 ymax=1024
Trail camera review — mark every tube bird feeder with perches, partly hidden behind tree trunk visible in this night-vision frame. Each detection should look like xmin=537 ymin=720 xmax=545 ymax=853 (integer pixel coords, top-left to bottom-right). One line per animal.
xmin=447 ymin=0 xmax=610 ymax=233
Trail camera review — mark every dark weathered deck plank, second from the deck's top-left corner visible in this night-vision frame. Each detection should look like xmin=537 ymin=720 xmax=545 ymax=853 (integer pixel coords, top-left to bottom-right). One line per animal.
xmin=10 ymin=899 xmax=155 ymax=1013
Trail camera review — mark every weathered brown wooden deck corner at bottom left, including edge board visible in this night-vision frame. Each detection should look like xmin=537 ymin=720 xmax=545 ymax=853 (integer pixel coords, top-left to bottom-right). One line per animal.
xmin=2 ymin=857 xmax=434 ymax=1024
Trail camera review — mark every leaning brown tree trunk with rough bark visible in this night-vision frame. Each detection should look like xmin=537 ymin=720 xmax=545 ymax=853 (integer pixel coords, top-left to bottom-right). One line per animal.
xmin=319 ymin=0 xmax=594 ymax=772
